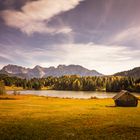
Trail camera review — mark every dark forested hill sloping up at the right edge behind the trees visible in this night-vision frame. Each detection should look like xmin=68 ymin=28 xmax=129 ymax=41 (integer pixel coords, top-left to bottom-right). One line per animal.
xmin=114 ymin=67 xmax=140 ymax=79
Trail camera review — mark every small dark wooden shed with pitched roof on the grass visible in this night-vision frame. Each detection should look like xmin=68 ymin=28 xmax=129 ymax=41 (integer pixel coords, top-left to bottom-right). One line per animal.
xmin=113 ymin=90 xmax=139 ymax=107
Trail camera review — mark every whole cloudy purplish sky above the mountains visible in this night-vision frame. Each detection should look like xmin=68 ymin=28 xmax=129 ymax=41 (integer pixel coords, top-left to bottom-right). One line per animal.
xmin=0 ymin=0 xmax=140 ymax=74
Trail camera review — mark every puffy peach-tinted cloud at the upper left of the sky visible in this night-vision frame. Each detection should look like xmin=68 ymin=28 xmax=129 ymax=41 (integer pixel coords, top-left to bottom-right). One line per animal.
xmin=1 ymin=0 xmax=82 ymax=35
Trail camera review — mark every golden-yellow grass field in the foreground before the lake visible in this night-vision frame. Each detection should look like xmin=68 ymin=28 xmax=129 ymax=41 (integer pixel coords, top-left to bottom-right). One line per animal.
xmin=0 ymin=95 xmax=140 ymax=140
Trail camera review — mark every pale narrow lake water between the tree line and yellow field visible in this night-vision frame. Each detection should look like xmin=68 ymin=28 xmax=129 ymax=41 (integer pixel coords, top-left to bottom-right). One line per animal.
xmin=8 ymin=90 xmax=138 ymax=99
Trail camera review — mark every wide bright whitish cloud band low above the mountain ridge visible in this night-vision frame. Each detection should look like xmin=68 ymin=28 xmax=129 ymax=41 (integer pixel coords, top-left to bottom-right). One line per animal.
xmin=1 ymin=43 xmax=140 ymax=74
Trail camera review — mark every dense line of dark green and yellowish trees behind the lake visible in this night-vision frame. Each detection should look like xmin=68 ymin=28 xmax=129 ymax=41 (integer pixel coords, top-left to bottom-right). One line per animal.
xmin=0 ymin=74 xmax=140 ymax=92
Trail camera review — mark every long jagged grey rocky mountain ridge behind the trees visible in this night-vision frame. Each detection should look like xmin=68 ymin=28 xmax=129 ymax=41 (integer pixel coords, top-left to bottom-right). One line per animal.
xmin=0 ymin=64 xmax=103 ymax=78
